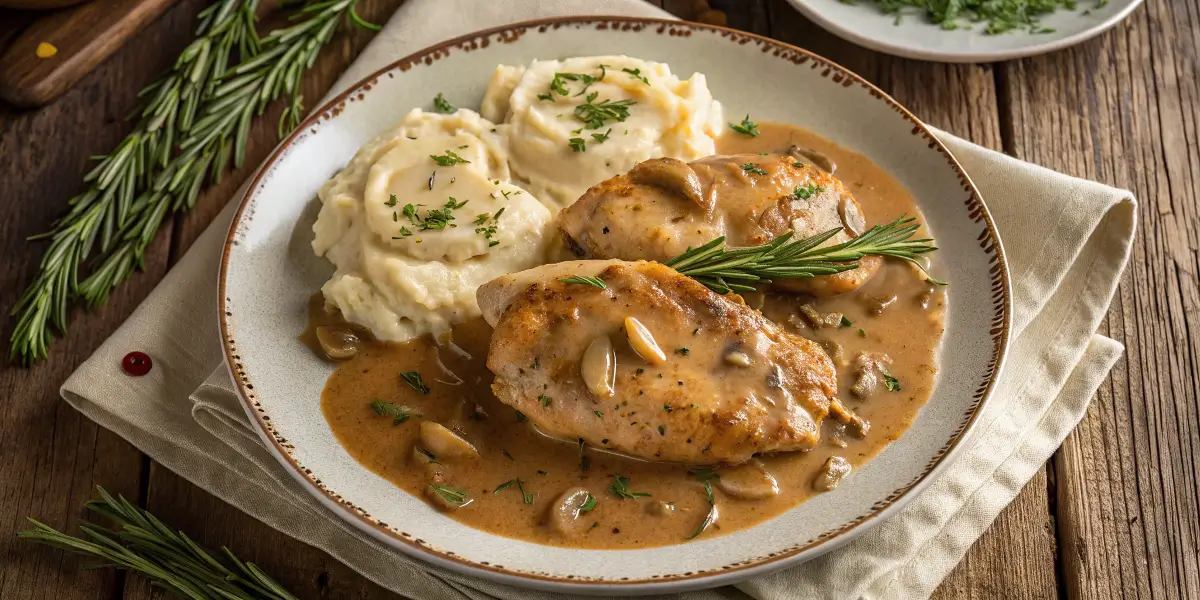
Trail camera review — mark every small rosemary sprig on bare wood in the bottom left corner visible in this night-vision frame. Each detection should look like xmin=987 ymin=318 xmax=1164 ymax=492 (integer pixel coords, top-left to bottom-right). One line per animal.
xmin=17 ymin=487 xmax=296 ymax=600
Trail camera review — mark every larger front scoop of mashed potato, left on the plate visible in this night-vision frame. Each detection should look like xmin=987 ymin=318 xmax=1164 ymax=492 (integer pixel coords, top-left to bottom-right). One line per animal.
xmin=312 ymin=109 xmax=551 ymax=341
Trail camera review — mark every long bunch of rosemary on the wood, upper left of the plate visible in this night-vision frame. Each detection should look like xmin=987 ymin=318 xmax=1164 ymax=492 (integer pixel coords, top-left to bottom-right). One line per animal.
xmin=10 ymin=0 xmax=378 ymax=364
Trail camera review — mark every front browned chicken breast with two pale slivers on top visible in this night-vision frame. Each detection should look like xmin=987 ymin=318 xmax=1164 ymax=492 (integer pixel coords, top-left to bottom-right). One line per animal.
xmin=478 ymin=260 xmax=866 ymax=464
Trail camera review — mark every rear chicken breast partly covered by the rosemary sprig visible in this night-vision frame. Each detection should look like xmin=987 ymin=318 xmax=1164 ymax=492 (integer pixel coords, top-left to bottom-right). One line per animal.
xmin=558 ymin=149 xmax=882 ymax=296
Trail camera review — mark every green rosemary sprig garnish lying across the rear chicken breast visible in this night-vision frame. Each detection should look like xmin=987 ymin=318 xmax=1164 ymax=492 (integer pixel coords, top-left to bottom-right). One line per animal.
xmin=666 ymin=216 xmax=937 ymax=294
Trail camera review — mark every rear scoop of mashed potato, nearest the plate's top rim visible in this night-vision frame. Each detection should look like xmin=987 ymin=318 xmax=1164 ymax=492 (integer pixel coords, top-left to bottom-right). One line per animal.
xmin=481 ymin=56 xmax=724 ymax=211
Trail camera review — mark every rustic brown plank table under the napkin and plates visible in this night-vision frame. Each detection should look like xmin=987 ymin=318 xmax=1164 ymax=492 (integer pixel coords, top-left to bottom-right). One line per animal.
xmin=0 ymin=0 xmax=1200 ymax=600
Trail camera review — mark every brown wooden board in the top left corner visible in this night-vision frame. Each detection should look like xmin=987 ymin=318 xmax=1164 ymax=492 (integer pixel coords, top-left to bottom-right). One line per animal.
xmin=0 ymin=0 xmax=175 ymax=107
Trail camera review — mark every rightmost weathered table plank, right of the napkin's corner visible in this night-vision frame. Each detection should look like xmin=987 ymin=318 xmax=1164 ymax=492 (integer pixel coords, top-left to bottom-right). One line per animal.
xmin=1002 ymin=0 xmax=1200 ymax=599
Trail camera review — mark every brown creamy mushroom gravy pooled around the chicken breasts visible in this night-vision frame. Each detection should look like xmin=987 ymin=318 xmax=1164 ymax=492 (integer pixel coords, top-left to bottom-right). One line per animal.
xmin=316 ymin=124 xmax=946 ymax=548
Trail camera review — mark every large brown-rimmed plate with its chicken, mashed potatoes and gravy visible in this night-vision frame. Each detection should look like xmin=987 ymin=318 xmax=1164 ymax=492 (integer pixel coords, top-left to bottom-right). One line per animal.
xmin=221 ymin=17 xmax=1010 ymax=594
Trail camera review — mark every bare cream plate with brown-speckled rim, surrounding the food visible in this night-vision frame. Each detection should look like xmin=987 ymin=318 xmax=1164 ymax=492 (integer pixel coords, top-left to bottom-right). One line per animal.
xmin=220 ymin=17 xmax=1010 ymax=594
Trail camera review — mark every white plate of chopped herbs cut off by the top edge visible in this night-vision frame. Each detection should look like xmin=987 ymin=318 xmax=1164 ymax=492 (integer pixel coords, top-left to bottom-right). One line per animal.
xmin=787 ymin=0 xmax=1142 ymax=62
